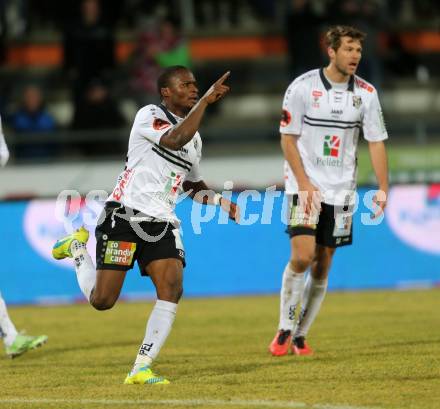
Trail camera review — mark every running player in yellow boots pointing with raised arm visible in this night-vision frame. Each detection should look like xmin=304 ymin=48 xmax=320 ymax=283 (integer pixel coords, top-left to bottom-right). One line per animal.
xmin=53 ymin=66 xmax=239 ymax=384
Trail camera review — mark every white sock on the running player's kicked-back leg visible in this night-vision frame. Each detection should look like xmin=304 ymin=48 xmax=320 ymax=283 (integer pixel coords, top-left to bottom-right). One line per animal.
xmin=70 ymin=240 xmax=96 ymax=301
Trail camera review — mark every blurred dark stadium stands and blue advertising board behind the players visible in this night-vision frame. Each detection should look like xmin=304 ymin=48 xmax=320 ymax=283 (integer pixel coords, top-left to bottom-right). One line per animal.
xmin=0 ymin=0 xmax=440 ymax=303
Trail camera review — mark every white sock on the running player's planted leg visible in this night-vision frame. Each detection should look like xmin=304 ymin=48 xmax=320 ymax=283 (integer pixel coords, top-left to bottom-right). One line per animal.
xmin=133 ymin=300 xmax=177 ymax=372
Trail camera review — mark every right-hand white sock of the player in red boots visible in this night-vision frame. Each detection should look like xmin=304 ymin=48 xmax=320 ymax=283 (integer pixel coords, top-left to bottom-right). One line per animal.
xmin=295 ymin=274 xmax=328 ymax=337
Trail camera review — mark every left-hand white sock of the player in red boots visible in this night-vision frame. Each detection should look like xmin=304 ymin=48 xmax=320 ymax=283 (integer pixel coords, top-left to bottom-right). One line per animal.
xmin=278 ymin=262 xmax=304 ymax=331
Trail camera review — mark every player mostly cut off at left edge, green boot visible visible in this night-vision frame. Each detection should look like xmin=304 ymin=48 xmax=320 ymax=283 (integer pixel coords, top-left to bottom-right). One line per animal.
xmin=0 ymin=117 xmax=47 ymax=358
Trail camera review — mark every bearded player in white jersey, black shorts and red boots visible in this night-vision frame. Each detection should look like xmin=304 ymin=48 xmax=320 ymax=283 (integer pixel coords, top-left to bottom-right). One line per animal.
xmin=269 ymin=26 xmax=388 ymax=356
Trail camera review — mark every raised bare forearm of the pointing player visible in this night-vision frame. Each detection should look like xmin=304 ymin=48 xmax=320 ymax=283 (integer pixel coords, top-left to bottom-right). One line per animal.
xmin=160 ymin=98 xmax=208 ymax=151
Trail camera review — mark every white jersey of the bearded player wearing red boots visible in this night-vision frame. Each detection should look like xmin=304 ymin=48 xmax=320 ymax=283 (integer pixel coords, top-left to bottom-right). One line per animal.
xmin=280 ymin=68 xmax=388 ymax=205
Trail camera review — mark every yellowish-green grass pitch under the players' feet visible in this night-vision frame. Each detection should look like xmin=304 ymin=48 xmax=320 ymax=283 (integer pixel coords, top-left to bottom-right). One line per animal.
xmin=0 ymin=289 xmax=440 ymax=409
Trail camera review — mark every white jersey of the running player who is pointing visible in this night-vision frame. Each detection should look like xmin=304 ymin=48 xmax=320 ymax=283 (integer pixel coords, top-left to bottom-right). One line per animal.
xmin=107 ymin=104 xmax=202 ymax=223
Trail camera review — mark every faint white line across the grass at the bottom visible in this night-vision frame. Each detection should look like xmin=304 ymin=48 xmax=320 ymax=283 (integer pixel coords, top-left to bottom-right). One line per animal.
xmin=0 ymin=398 xmax=380 ymax=409
